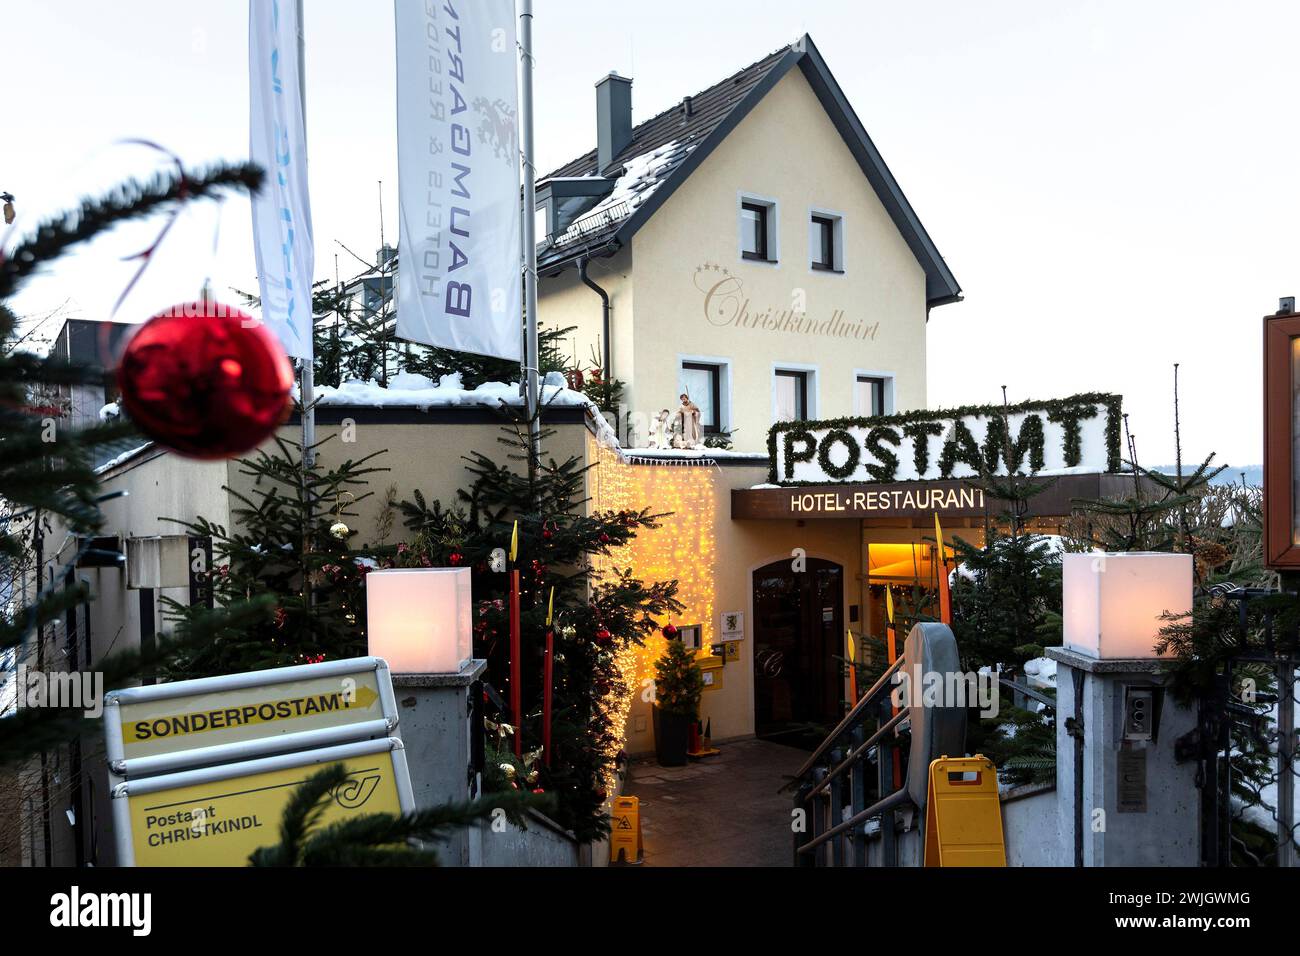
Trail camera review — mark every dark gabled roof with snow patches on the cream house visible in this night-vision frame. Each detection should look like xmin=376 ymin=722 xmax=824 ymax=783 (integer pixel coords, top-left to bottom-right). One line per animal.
xmin=538 ymin=34 xmax=961 ymax=306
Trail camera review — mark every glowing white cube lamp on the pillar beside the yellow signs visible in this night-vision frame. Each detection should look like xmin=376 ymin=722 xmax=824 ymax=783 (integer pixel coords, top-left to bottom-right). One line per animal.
xmin=365 ymin=567 xmax=473 ymax=674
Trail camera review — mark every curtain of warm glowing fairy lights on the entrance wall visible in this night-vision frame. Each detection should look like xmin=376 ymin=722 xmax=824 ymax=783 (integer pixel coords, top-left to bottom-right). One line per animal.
xmin=588 ymin=436 xmax=718 ymax=792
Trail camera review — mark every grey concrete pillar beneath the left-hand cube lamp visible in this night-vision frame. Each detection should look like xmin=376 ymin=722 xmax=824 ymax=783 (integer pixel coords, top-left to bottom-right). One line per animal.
xmin=393 ymin=661 xmax=488 ymax=866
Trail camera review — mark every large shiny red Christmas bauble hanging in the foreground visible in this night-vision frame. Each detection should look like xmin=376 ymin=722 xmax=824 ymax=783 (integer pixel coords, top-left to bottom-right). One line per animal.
xmin=117 ymin=302 xmax=294 ymax=459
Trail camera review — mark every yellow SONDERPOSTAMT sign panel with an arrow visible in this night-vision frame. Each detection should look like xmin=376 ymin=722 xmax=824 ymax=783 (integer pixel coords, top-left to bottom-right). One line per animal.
xmin=120 ymin=669 xmax=384 ymax=760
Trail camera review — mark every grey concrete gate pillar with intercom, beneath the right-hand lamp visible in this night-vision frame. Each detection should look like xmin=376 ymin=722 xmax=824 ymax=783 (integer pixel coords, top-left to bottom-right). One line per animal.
xmin=1047 ymin=648 xmax=1200 ymax=866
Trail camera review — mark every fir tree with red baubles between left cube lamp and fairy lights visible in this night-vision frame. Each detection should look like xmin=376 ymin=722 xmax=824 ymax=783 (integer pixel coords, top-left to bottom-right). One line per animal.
xmin=397 ymin=411 xmax=681 ymax=840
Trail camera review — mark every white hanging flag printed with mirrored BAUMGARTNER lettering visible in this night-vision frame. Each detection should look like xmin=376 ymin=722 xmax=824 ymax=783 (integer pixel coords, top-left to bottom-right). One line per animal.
xmin=394 ymin=0 xmax=523 ymax=360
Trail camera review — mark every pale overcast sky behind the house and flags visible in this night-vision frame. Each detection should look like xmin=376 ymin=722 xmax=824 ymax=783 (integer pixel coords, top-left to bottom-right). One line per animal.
xmin=0 ymin=0 xmax=1300 ymax=464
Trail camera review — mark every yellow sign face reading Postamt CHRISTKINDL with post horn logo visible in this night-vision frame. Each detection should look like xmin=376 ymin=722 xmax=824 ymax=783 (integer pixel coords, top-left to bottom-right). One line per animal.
xmin=127 ymin=750 xmax=402 ymax=866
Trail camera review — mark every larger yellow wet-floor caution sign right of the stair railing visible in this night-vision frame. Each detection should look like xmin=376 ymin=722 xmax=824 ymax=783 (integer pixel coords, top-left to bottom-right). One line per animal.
xmin=926 ymin=754 xmax=1006 ymax=866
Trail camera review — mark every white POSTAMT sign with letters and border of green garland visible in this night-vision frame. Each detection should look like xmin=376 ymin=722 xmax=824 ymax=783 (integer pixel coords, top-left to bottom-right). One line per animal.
xmin=767 ymin=393 xmax=1121 ymax=485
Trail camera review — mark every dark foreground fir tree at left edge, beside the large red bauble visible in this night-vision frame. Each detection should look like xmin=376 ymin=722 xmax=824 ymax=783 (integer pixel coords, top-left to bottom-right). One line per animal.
xmin=0 ymin=164 xmax=271 ymax=764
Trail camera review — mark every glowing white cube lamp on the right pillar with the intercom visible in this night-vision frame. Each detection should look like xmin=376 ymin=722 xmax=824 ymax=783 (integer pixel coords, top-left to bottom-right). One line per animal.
xmin=1061 ymin=551 xmax=1192 ymax=661
